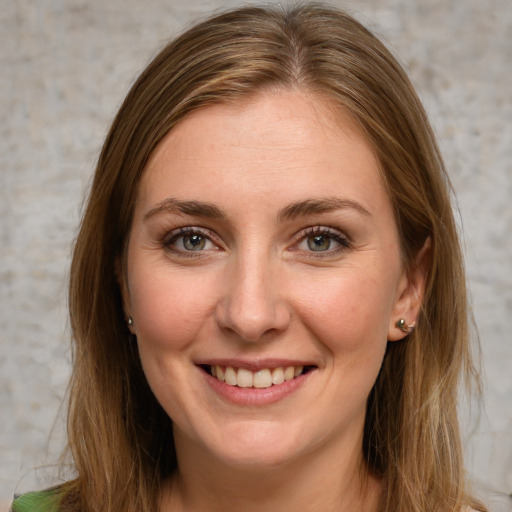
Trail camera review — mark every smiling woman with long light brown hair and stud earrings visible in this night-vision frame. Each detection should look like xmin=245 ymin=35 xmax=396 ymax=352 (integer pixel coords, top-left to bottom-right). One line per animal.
xmin=14 ymin=5 xmax=485 ymax=512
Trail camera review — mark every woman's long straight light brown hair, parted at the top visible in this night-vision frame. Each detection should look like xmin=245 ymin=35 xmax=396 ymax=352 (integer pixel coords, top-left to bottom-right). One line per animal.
xmin=60 ymin=4 xmax=485 ymax=512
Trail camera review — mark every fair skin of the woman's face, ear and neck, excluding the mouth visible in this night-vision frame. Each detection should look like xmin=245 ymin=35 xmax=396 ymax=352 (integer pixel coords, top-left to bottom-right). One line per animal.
xmin=122 ymin=91 xmax=425 ymax=511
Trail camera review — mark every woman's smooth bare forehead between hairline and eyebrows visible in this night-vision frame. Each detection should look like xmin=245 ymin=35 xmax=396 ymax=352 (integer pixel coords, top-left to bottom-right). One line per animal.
xmin=139 ymin=91 xmax=387 ymax=218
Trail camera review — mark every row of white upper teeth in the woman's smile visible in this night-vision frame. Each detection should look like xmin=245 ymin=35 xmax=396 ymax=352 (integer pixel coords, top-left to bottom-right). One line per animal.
xmin=211 ymin=366 xmax=304 ymax=388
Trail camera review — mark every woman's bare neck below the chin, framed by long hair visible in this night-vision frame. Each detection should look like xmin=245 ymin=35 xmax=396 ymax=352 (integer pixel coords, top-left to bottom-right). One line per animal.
xmin=161 ymin=432 xmax=381 ymax=512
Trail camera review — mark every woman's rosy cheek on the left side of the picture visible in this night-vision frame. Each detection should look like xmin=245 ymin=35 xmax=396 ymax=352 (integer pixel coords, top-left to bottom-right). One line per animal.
xmin=129 ymin=264 xmax=219 ymax=414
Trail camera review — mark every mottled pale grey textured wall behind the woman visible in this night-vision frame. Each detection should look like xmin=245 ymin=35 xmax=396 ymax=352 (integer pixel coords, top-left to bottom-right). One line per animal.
xmin=0 ymin=0 xmax=512 ymax=510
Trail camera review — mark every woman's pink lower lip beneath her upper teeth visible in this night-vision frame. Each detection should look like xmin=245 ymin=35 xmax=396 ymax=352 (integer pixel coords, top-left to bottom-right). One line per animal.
xmin=201 ymin=369 xmax=315 ymax=405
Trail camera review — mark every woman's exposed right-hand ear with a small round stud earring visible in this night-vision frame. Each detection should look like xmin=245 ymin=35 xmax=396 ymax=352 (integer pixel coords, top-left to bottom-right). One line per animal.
xmin=388 ymin=237 xmax=432 ymax=341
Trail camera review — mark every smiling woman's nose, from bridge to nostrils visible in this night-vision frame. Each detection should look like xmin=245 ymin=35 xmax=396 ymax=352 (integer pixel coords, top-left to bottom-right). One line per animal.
xmin=216 ymin=255 xmax=291 ymax=342
